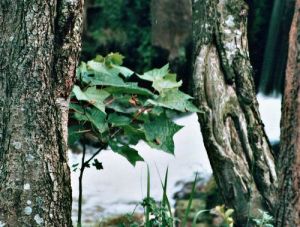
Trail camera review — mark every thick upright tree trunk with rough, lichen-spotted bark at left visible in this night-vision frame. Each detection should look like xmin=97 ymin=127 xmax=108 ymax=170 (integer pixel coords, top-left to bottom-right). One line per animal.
xmin=0 ymin=0 xmax=83 ymax=227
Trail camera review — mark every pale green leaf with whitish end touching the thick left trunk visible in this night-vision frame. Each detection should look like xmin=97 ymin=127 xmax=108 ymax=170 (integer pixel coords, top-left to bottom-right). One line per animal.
xmin=73 ymin=85 xmax=110 ymax=113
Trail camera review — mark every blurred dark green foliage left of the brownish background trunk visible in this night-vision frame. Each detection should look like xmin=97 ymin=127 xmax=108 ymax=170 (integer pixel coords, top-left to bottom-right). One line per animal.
xmin=82 ymin=0 xmax=167 ymax=72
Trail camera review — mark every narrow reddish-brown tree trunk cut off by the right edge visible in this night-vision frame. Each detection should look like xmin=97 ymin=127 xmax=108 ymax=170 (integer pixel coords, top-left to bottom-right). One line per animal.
xmin=276 ymin=0 xmax=300 ymax=226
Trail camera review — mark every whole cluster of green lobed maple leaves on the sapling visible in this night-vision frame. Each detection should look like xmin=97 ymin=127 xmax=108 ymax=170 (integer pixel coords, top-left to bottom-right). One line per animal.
xmin=69 ymin=53 xmax=198 ymax=165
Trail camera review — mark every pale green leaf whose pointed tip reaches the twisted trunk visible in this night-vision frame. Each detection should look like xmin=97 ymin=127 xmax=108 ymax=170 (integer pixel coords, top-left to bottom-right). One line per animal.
xmin=148 ymin=89 xmax=199 ymax=112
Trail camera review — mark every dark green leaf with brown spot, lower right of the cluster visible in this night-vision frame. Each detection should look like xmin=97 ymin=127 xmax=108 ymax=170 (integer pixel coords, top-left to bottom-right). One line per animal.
xmin=144 ymin=115 xmax=182 ymax=154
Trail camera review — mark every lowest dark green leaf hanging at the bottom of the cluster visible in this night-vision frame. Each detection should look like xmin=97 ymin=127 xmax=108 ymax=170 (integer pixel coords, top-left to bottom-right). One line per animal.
xmin=108 ymin=140 xmax=144 ymax=166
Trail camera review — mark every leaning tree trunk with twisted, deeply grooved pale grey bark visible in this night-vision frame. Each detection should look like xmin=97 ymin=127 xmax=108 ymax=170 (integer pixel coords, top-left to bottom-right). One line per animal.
xmin=193 ymin=0 xmax=278 ymax=226
